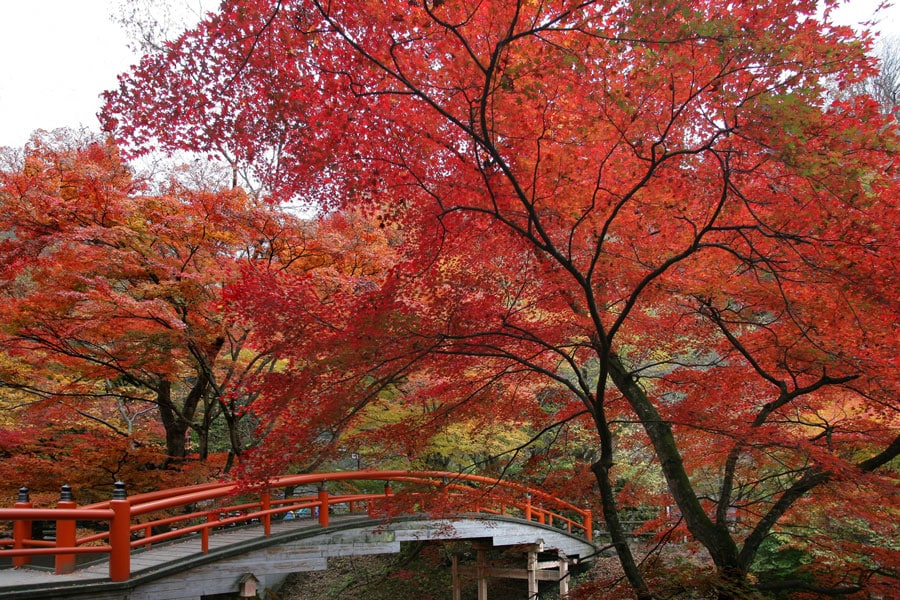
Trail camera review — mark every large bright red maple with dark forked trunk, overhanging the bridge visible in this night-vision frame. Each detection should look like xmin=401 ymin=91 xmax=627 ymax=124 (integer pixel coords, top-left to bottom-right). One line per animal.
xmin=105 ymin=0 xmax=900 ymax=598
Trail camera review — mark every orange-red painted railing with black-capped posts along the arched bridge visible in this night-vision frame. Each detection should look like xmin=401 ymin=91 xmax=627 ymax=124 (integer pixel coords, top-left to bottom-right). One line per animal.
xmin=0 ymin=471 xmax=593 ymax=581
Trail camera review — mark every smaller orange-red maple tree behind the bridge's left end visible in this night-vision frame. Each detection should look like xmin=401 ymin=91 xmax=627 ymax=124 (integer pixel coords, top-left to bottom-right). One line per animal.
xmin=0 ymin=136 xmax=334 ymax=474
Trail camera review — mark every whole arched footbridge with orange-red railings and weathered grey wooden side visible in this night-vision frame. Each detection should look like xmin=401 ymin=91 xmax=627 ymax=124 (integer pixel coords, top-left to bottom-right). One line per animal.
xmin=0 ymin=471 xmax=595 ymax=598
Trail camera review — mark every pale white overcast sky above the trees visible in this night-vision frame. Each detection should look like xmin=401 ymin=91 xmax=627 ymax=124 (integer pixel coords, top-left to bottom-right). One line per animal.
xmin=0 ymin=0 xmax=900 ymax=146
